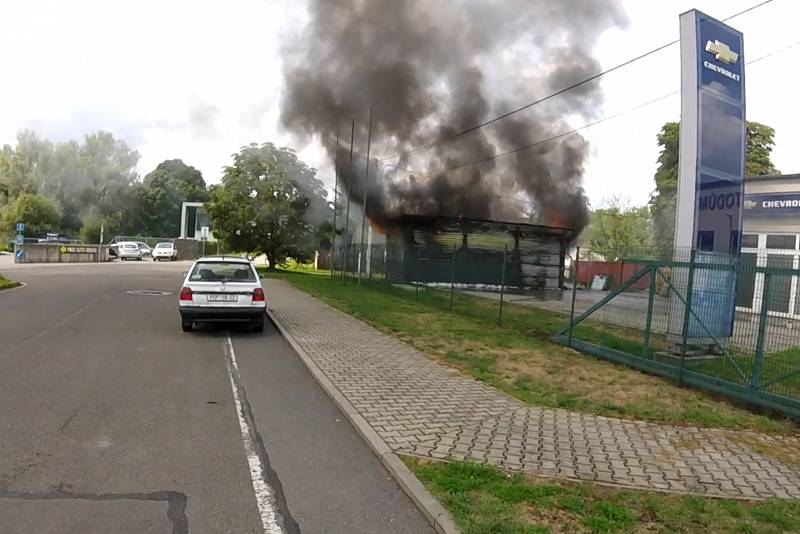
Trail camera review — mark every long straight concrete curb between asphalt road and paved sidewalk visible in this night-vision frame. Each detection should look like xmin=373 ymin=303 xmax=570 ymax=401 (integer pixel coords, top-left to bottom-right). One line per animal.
xmin=267 ymin=307 xmax=461 ymax=534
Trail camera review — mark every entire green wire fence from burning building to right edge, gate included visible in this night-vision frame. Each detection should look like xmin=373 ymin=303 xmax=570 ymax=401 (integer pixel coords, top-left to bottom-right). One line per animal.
xmin=322 ymin=242 xmax=800 ymax=416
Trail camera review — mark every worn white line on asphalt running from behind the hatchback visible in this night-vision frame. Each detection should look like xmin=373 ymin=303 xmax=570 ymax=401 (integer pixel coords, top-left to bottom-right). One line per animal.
xmin=225 ymin=333 xmax=285 ymax=534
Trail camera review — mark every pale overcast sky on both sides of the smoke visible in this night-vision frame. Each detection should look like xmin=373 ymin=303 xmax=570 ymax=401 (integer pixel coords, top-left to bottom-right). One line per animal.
xmin=0 ymin=0 xmax=800 ymax=211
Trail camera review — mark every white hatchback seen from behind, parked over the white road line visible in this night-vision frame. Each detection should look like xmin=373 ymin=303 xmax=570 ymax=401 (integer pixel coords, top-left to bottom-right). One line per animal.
xmin=178 ymin=256 xmax=267 ymax=332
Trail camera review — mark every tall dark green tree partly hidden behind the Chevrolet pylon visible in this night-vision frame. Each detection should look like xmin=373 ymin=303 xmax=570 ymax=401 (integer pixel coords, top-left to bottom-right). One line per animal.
xmin=650 ymin=121 xmax=780 ymax=249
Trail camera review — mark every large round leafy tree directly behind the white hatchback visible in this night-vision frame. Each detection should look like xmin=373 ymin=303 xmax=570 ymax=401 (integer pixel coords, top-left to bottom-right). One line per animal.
xmin=208 ymin=143 xmax=324 ymax=269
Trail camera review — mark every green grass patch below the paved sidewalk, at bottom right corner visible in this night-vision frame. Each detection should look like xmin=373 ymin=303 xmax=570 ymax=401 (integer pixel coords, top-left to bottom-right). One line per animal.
xmin=404 ymin=457 xmax=800 ymax=534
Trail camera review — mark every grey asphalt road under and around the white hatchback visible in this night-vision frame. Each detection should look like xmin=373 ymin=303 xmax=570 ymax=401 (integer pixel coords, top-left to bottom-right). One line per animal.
xmin=0 ymin=258 xmax=432 ymax=534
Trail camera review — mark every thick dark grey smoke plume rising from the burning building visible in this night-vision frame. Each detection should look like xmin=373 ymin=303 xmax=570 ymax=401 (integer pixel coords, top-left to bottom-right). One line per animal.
xmin=281 ymin=0 xmax=625 ymax=234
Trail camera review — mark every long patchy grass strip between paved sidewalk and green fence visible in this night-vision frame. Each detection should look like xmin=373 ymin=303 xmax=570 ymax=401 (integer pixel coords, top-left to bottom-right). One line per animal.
xmin=268 ymin=271 xmax=797 ymax=433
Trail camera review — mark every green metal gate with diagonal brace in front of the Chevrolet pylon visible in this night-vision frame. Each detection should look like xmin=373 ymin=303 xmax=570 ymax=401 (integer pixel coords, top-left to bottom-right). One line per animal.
xmin=555 ymin=250 xmax=800 ymax=416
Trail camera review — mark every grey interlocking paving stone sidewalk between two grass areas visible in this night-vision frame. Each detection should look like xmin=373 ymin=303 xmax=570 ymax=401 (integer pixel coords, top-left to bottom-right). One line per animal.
xmin=265 ymin=280 xmax=800 ymax=498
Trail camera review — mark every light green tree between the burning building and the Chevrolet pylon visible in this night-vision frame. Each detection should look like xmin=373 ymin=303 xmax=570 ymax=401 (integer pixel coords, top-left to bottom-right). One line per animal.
xmin=583 ymin=197 xmax=652 ymax=261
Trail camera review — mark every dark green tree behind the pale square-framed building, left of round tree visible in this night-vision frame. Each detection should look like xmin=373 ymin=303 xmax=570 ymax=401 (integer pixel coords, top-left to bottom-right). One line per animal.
xmin=135 ymin=159 xmax=209 ymax=237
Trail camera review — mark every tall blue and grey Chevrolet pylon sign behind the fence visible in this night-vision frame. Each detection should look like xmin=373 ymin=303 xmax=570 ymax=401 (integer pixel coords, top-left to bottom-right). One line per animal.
xmin=671 ymin=10 xmax=746 ymax=338
